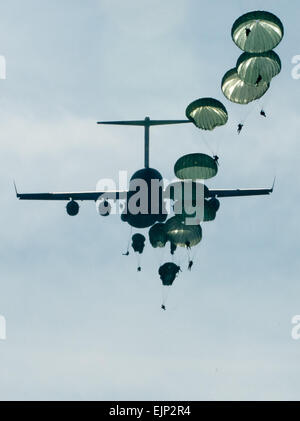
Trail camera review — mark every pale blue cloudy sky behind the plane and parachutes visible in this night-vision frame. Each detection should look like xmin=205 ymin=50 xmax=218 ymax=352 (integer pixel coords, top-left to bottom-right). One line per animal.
xmin=0 ymin=0 xmax=300 ymax=400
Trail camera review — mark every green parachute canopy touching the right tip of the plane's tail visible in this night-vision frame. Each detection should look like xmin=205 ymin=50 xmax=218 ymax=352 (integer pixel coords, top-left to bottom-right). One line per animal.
xmin=185 ymin=98 xmax=228 ymax=130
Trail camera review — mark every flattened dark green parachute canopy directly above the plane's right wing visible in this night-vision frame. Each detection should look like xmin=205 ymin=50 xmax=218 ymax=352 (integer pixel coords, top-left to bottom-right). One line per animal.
xmin=174 ymin=153 xmax=218 ymax=180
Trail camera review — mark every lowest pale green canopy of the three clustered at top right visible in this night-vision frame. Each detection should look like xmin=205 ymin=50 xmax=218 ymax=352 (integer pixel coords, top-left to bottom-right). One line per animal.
xmin=221 ymin=68 xmax=270 ymax=104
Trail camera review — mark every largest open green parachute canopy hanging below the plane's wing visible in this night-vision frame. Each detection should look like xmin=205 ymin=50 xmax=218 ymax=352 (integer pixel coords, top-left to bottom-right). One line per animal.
xmin=165 ymin=216 xmax=202 ymax=247
